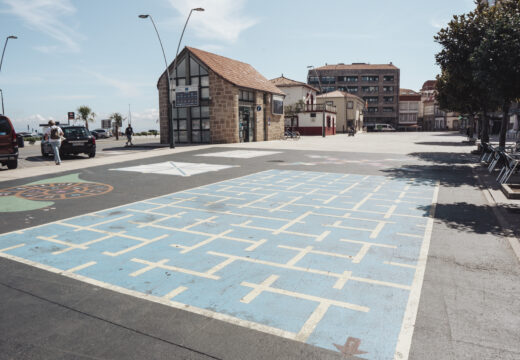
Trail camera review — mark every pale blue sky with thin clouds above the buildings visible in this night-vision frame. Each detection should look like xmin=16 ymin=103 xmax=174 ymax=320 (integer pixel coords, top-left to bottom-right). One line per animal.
xmin=0 ymin=0 xmax=475 ymax=131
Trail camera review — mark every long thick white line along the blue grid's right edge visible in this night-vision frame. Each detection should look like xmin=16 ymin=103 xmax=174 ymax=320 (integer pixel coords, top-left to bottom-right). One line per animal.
xmin=394 ymin=182 xmax=440 ymax=360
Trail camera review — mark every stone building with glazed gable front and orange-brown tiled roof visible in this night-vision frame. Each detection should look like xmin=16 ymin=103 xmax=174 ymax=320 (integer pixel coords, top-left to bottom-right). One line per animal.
xmin=157 ymin=47 xmax=285 ymax=144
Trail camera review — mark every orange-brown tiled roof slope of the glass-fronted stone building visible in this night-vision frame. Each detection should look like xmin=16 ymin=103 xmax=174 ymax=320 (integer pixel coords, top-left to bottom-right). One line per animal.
xmin=186 ymin=46 xmax=285 ymax=95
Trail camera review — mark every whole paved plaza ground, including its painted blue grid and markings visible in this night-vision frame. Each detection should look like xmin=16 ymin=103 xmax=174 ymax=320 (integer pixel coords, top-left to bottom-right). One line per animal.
xmin=0 ymin=133 xmax=520 ymax=359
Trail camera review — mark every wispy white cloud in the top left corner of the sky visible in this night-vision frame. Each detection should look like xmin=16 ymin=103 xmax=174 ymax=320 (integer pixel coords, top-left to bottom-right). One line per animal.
xmin=2 ymin=0 xmax=83 ymax=52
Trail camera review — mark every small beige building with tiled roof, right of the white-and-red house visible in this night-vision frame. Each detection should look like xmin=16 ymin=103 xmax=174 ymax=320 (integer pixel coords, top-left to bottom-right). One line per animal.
xmin=318 ymin=90 xmax=365 ymax=133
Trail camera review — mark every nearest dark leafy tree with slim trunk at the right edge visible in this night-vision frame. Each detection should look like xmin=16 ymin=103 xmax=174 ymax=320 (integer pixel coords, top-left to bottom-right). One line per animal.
xmin=471 ymin=0 xmax=520 ymax=148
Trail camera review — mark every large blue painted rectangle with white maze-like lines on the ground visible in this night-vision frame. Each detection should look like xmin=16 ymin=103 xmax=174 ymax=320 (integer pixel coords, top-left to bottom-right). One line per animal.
xmin=0 ymin=170 xmax=435 ymax=359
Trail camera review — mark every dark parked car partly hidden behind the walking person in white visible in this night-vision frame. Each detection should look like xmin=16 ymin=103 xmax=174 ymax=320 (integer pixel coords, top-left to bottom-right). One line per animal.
xmin=41 ymin=126 xmax=96 ymax=157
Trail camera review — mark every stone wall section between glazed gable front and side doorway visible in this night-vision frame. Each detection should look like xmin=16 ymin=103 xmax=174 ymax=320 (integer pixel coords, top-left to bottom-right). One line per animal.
xmin=209 ymin=70 xmax=239 ymax=144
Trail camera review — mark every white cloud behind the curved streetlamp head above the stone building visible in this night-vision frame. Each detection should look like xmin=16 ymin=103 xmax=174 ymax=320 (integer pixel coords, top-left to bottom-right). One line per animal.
xmin=170 ymin=0 xmax=258 ymax=43
